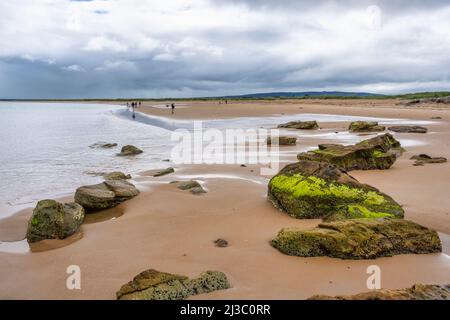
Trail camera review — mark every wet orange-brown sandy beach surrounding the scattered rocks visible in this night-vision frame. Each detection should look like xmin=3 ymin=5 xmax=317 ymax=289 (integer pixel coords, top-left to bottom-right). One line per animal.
xmin=0 ymin=99 xmax=450 ymax=299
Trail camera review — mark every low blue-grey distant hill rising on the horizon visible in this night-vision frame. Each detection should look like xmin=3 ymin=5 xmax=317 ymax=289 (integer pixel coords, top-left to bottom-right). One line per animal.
xmin=222 ymin=91 xmax=384 ymax=99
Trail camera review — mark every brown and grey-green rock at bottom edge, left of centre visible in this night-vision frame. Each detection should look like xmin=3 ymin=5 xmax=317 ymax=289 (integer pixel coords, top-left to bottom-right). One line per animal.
xmin=116 ymin=269 xmax=230 ymax=300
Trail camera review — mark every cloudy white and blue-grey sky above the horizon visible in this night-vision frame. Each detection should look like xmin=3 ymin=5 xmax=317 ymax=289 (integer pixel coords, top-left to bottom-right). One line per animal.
xmin=0 ymin=0 xmax=450 ymax=99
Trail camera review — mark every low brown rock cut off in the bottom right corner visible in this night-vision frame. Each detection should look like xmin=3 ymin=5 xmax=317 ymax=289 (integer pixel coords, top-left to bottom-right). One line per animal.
xmin=308 ymin=284 xmax=450 ymax=300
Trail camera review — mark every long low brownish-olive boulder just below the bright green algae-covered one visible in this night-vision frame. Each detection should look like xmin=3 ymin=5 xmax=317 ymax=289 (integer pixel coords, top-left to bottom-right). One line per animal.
xmin=272 ymin=218 xmax=442 ymax=259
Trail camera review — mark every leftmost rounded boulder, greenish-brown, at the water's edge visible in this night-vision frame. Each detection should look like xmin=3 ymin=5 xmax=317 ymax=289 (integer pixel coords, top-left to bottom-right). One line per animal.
xmin=27 ymin=200 xmax=84 ymax=243
